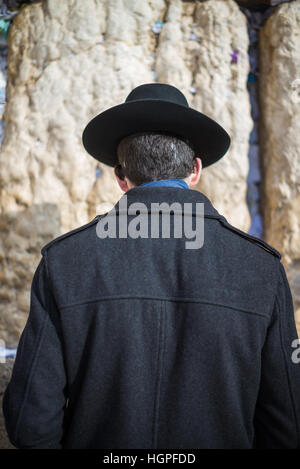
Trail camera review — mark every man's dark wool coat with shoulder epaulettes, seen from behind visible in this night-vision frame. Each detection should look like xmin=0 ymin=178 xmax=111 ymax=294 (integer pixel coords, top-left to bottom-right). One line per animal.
xmin=3 ymin=186 xmax=300 ymax=449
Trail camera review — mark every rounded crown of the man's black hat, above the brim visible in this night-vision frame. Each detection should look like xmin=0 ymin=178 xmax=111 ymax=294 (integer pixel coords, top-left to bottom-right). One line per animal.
xmin=125 ymin=83 xmax=189 ymax=107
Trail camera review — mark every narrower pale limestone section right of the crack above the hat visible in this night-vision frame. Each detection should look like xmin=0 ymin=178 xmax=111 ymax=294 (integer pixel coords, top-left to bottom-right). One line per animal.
xmin=156 ymin=0 xmax=253 ymax=231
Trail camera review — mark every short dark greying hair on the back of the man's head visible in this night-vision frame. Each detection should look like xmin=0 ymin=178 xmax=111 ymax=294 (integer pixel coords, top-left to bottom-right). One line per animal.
xmin=116 ymin=132 xmax=195 ymax=186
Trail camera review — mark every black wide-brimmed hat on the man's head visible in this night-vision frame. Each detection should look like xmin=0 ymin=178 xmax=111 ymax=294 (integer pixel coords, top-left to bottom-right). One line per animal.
xmin=82 ymin=83 xmax=230 ymax=168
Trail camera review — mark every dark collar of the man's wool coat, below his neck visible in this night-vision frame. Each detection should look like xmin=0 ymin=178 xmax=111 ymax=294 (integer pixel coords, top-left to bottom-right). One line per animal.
xmin=114 ymin=186 xmax=226 ymax=221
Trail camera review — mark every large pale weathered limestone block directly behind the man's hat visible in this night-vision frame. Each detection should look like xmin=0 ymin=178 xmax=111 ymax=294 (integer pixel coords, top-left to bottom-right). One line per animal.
xmin=0 ymin=0 xmax=252 ymax=345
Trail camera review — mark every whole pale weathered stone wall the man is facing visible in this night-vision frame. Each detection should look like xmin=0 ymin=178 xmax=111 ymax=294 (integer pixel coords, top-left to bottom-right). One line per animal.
xmin=0 ymin=0 xmax=300 ymax=448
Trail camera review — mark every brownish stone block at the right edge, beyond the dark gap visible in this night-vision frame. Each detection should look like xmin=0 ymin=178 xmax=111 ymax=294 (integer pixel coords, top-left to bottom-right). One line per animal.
xmin=260 ymin=0 xmax=300 ymax=332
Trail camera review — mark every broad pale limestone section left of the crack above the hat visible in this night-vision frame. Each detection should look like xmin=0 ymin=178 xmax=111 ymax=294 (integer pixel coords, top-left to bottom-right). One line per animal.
xmin=0 ymin=0 xmax=166 ymax=345
